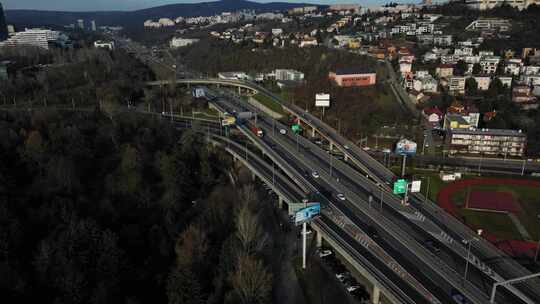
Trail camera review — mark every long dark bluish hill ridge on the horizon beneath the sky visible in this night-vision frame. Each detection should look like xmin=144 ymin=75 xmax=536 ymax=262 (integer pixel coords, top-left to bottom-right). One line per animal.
xmin=6 ymin=0 xmax=320 ymax=26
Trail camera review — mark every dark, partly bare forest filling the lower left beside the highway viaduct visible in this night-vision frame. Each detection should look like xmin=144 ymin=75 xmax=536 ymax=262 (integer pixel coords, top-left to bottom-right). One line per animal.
xmin=0 ymin=109 xmax=279 ymax=304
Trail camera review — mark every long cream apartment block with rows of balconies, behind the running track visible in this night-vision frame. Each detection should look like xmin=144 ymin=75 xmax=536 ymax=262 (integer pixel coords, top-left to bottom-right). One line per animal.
xmin=446 ymin=129 xmax=527 ymax=157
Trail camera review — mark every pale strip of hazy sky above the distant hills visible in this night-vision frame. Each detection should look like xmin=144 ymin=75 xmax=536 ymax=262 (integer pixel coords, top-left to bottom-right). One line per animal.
xmin=0 ymin=0 xmax=396 ymax=11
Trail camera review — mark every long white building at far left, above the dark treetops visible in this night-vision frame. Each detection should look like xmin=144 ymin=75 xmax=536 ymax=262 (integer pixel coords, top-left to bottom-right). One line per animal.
xmin=0 ymin=28 xmax=68 ymax=50
